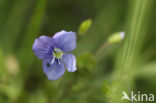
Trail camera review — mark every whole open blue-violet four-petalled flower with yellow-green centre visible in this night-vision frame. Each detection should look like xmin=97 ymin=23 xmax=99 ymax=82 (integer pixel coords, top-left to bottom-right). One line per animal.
xmin=33 ymin=30 xmax=76 ymax=80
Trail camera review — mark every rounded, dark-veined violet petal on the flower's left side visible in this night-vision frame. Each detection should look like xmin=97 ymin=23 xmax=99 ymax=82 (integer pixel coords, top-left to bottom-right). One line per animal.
xmin=33 ymin=36 xmax=54 ymax=60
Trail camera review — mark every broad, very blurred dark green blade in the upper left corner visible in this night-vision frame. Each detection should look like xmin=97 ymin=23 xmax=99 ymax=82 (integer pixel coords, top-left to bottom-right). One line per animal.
xmin=1 ymin=0 xmax=30 ymax=51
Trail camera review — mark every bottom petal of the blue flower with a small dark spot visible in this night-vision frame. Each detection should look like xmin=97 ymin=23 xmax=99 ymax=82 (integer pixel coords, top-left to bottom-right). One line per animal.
xmin=42 ymin=59 xmax=65 ymax=81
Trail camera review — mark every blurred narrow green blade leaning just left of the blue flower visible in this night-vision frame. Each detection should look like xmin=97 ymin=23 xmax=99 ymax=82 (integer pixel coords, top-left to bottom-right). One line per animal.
xmin=19 ymin=0 xmax=47 ymax=72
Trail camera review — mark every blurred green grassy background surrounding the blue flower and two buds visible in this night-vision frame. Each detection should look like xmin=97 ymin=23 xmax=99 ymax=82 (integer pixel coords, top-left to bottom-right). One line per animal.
xmin=0 ymin=0 xmax=156 ymax=103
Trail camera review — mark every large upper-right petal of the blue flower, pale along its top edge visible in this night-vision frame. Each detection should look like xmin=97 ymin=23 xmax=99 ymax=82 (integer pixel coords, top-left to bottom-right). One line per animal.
xmin=53 ymin=30 xmax=76 ymax=52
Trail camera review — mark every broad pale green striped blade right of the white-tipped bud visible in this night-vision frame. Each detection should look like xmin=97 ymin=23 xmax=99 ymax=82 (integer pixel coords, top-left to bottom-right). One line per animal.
xmin=112 ymin=0 xmax=154 ymax=102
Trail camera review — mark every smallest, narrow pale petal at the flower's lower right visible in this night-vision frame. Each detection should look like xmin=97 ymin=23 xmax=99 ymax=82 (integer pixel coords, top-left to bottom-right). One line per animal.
xmin=63 ymin=53 xmax=77 ymax=72
